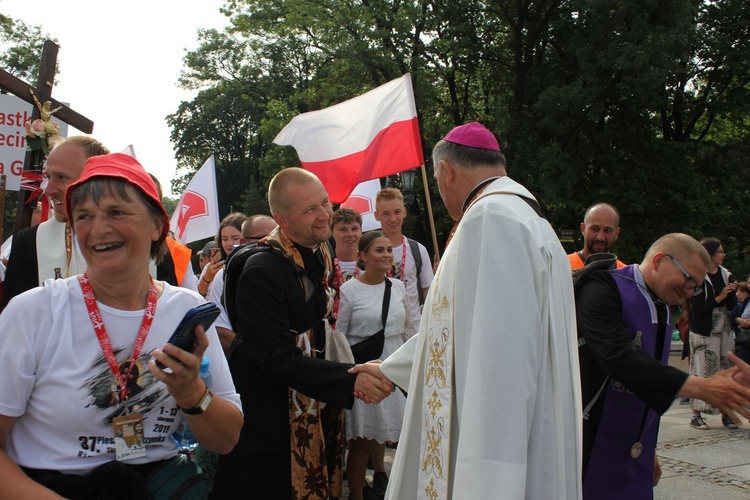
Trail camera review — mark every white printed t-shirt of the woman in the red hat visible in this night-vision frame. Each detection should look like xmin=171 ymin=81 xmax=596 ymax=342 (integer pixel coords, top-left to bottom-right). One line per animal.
xmin=0 ymin=277 xmax=241 ymax=474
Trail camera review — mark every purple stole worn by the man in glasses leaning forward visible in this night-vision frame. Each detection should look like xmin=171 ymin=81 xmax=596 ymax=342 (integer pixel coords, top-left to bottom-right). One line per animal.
xmin=583 ymin=265 xmax=672 ymax=500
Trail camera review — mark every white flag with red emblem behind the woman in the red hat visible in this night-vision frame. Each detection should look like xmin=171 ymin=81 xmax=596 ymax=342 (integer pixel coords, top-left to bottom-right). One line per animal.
xmin=169 ymin=156 xmax=219 ymax=244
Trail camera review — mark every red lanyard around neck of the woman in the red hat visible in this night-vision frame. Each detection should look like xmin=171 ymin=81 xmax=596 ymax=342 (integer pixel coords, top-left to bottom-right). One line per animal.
xmin=78 ymin=271 xmax=156 ymax=400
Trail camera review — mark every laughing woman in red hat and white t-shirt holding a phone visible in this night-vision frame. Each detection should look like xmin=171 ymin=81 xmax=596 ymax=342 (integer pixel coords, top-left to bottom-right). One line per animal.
xmin=0 ymin=153 xmax=243 ymax=498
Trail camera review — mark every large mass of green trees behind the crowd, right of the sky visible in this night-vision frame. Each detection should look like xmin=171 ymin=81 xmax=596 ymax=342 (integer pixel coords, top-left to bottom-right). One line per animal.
xmin=170 ymin=0 xmax=750 ymax=270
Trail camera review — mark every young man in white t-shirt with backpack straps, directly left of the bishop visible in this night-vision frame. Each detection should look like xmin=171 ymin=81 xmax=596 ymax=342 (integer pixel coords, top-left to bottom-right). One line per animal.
xmin=375 ymin=188 xmax=433 ymax=336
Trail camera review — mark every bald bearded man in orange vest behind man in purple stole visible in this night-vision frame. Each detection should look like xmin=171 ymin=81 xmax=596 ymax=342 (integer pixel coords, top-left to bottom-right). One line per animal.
xmin=568 ymin=202 xmax=625 ymax=271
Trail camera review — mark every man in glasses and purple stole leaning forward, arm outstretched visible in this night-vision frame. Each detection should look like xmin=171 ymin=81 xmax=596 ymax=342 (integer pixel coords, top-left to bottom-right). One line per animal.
xmin=576 ymin=233 xmax=750 ymax=499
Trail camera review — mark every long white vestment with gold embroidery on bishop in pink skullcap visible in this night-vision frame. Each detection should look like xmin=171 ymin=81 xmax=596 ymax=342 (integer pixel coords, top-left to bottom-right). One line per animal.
xmin=381 ymin=177 xmax=582 ymax=500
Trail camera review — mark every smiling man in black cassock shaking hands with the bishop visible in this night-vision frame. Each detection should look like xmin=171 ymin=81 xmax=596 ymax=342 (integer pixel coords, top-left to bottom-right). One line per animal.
xmin=217 ymin=168 xmax=393 ymax=500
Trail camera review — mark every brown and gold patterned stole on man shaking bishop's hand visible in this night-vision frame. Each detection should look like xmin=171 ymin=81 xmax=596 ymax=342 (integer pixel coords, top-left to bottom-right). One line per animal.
xmin=259 ymin=227 xmax=344 ymax=500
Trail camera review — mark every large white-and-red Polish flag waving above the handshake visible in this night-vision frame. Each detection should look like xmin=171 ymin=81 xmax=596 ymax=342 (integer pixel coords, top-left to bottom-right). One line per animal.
xmin=273 ymin=73 xmax=424 ymax=203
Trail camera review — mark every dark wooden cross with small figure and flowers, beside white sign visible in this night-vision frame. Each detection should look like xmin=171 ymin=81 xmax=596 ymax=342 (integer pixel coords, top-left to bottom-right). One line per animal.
xmin=0 ymin=40 xmax=94 ymax=234
